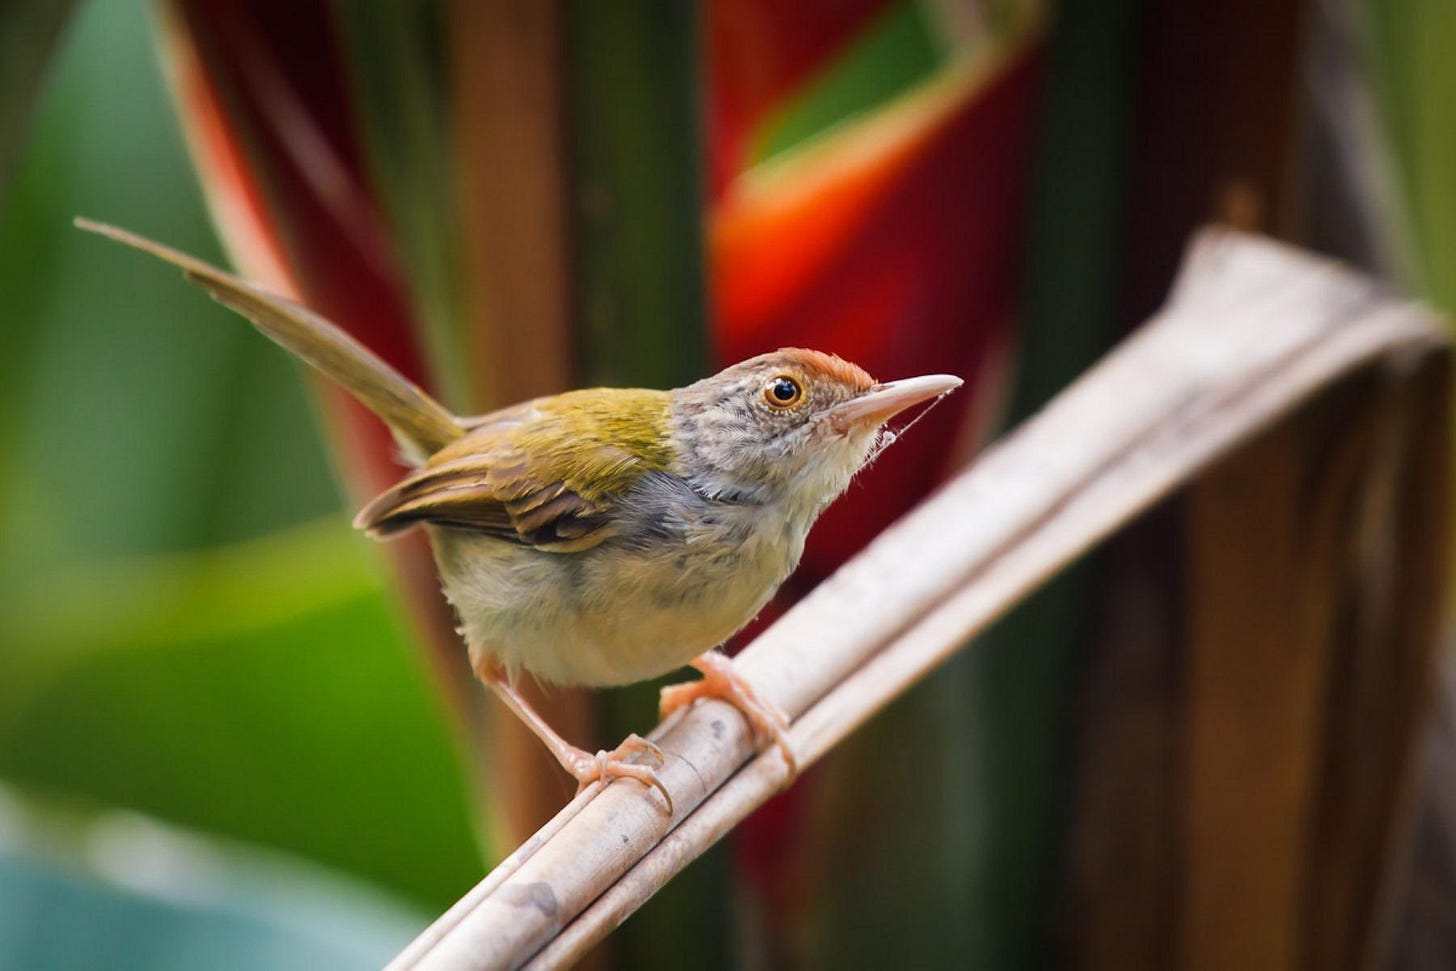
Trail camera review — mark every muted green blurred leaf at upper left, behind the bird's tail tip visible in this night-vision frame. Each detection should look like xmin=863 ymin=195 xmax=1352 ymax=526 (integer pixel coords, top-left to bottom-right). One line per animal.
xmin=0 ymin=1 xmax=339 ymax=570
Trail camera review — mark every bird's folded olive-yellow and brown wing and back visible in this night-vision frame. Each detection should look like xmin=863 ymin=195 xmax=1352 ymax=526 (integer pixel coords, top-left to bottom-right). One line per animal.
xmin=354 ymin=389 xmax=674 ymax=553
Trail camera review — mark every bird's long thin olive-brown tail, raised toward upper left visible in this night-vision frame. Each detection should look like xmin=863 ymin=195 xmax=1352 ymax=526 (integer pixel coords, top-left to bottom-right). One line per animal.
xmin=76 ymin=218 xmax=464 ymax=459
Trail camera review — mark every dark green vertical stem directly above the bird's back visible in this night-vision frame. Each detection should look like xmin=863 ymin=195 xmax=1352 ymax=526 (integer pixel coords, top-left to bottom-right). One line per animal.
xmin=566 ymin=0 xmax=708 ymax=387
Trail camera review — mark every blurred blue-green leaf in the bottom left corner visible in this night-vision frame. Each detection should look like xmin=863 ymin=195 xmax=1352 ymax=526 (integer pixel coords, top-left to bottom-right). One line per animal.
xmin=0 ymin=803 xmax=421 ymax=971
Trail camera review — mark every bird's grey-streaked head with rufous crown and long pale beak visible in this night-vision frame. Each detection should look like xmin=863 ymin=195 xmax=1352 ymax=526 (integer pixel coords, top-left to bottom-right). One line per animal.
xmin=673 ymin=348 xmax=961 ymax=515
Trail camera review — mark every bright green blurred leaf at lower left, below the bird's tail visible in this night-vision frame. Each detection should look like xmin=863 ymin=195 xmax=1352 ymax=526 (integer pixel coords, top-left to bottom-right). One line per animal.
xmin=0 ymin=521 xmax=480 ymax=905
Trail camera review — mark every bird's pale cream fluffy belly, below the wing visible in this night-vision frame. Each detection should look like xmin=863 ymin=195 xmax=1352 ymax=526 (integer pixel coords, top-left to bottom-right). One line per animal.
xmin=432 ymin=530 xmax=798 ymax=686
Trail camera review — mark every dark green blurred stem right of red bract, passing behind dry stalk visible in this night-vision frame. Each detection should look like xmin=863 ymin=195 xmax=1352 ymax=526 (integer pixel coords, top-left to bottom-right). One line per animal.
xmin=797 ymin=0 xmax=1140 ymax=968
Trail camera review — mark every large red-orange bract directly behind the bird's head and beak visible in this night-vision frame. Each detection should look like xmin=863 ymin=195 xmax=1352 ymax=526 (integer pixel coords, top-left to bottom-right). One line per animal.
xmin=711 ymin=48 xmax=1041 ymax=573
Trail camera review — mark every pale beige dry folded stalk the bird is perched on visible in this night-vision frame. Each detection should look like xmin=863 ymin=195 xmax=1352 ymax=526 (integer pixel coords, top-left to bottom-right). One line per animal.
xmin=392 ymin=231 xmax=1446 ymax=968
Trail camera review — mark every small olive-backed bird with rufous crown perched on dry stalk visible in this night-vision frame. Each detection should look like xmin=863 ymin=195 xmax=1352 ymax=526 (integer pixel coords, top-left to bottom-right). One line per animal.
xmin=76 ymin=218 xmax=961 ymax=812
